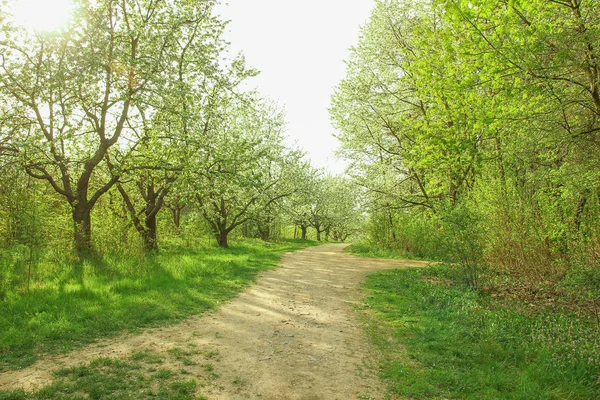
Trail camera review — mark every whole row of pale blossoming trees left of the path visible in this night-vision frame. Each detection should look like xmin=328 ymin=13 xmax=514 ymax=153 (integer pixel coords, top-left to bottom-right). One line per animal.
xmin=0 ymin=0 xmax=360 ymax=258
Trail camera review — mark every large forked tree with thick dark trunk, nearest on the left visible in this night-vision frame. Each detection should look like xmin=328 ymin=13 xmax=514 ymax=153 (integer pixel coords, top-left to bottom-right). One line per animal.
xmin=0 ymin=0 xmax=223 ymax=257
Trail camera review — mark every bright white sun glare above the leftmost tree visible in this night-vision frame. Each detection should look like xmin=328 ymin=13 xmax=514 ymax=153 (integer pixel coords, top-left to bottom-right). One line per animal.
xmin=12 ymin=0 xmax=73 ymax=32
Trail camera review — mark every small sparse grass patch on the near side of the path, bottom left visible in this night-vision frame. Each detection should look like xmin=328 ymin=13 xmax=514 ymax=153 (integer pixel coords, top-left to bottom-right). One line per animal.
xmin=0 ymin=353 xmax=204 ymax=400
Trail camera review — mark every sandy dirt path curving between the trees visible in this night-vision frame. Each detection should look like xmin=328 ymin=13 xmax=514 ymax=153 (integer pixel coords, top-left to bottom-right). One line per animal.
xmin=0 ymin=245 xmax=426 ymax=400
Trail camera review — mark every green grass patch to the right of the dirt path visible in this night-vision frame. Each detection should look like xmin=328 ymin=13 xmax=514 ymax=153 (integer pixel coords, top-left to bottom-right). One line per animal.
xmin=364 ymin=266 xmax=600 ymax=400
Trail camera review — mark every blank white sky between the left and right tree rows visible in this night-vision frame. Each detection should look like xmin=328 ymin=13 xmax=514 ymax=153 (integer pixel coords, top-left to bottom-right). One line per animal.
xmin=217 ymin=0 xmax=373 ymax=173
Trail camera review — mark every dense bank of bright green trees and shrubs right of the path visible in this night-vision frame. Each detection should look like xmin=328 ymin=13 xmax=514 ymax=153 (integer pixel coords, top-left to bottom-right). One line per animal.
xmin=331 ymin=0 xmax=600 ymax=288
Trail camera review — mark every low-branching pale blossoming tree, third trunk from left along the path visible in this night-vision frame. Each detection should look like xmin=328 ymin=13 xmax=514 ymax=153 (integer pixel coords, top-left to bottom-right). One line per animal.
xmin=189 ymin=95 xmax=297 ymax=247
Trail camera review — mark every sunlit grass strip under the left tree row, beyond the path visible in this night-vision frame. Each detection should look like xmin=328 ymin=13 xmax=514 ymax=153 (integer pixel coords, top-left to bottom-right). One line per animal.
xmin=0 ymin=241 xmax=314 ymax=372
